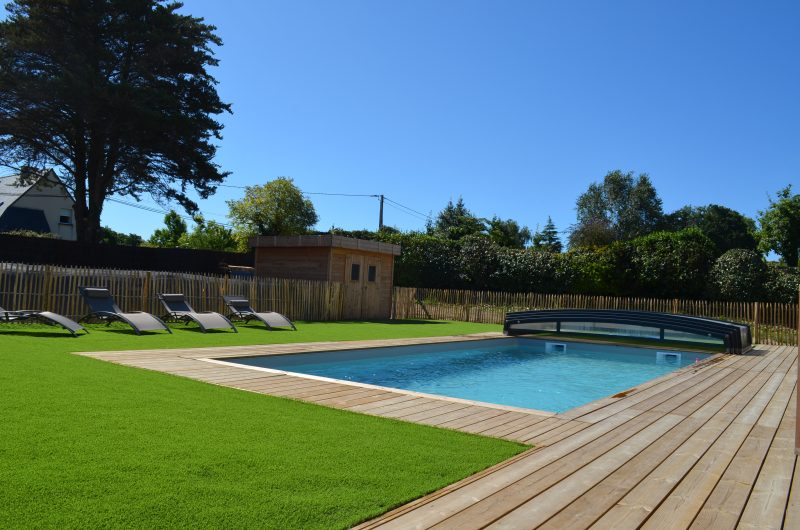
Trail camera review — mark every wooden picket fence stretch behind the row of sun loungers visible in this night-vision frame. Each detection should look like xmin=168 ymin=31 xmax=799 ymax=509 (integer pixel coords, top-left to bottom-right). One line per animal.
xmin=0 ymin=263 xmax=344 ymax=321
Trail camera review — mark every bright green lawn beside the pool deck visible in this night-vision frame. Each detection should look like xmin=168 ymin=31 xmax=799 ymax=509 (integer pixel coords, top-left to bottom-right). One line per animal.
xmin=0 ymin=322 xmax=524 ymax=528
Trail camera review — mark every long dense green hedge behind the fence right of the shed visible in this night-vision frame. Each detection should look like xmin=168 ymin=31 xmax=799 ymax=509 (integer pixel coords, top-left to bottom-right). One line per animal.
xmin=374 ymin=228 xmax=800 ymax=302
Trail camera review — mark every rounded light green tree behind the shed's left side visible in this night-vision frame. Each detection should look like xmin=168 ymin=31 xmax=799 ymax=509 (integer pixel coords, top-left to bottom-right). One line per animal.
xmin=228 ymin=177 xmax=318 ymax=236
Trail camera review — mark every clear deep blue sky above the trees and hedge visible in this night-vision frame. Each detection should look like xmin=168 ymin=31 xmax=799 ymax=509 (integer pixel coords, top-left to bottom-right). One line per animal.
xmin=84 ymin=0 xmax=800 ymax=236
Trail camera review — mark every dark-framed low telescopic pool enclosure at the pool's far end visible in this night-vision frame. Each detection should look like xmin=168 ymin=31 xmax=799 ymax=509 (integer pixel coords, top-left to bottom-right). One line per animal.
xmin=503 ymin=309 xmax=753 ymax=353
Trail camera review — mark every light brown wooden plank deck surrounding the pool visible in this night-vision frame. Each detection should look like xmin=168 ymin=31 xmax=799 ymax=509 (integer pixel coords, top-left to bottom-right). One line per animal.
xmin=78 ymin=335 xmax=800 ymax=529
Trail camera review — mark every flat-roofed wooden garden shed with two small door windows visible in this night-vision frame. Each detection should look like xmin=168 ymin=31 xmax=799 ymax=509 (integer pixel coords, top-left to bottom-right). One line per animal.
xmin=250 ymin=234 xmax=400 ymax=319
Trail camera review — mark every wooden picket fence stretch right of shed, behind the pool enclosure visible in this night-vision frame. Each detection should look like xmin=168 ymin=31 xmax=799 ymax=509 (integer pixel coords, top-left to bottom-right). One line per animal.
xmin=393 ymin=287 xmax=800 ymax=345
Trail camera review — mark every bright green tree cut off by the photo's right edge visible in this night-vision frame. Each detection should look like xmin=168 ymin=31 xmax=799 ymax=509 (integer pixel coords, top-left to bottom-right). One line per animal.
xmin=758 ymin=186 xmax=800 ymax=267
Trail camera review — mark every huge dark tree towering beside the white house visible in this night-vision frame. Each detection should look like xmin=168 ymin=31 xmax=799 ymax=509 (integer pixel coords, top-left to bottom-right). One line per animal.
xmin=0 ymin=0 xmax=230 ymax=241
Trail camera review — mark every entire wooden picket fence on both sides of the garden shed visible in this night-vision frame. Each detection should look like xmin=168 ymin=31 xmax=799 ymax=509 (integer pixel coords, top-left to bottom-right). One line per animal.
xmin=0 ymin=263 xmax=800 ymax=344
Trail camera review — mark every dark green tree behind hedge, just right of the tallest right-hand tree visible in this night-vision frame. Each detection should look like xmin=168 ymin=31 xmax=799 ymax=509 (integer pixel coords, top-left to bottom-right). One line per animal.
xmin=663 ymin=204 xmax=757 ymax=255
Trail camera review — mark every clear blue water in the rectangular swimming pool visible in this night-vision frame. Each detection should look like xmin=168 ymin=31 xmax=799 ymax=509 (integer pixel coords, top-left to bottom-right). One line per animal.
xmin=226 ymin=339 xmax=708 ymax=412
